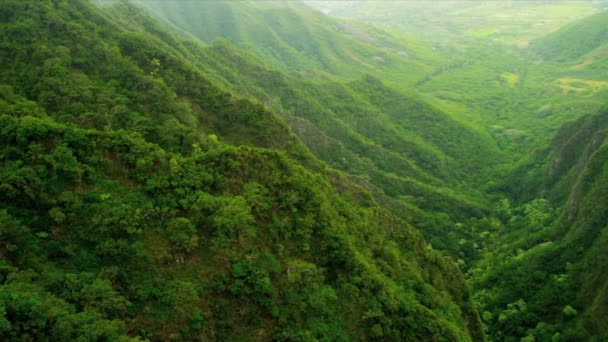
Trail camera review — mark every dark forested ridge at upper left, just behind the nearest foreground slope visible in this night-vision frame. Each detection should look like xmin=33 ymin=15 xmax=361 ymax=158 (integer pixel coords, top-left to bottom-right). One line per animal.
xmin=0 ymin=2 xmax=312 ymax=162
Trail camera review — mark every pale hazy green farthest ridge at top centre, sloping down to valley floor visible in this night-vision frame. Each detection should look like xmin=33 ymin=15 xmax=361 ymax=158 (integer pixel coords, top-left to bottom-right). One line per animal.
xmin=136 ymin=0 xmax=440 ymax=85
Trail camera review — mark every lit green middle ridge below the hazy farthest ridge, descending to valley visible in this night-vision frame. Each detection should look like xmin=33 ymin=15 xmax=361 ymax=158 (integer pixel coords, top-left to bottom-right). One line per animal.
xmin=196 ymin=42 xmax=498 ymax=190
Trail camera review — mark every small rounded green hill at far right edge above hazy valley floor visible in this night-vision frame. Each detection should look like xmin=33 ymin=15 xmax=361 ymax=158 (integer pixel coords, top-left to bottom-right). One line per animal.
xmin=532 ymin=11 xmax=608 ymax=62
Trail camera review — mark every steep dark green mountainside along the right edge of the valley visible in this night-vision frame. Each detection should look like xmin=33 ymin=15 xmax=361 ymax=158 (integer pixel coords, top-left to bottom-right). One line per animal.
xmin=484 ymin=111 xmax=608 ymax=340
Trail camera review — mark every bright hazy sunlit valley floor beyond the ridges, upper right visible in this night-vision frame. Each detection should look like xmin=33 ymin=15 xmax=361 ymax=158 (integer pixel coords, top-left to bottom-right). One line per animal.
xmin=307 ymin=0 xmax=608 ymax=152
